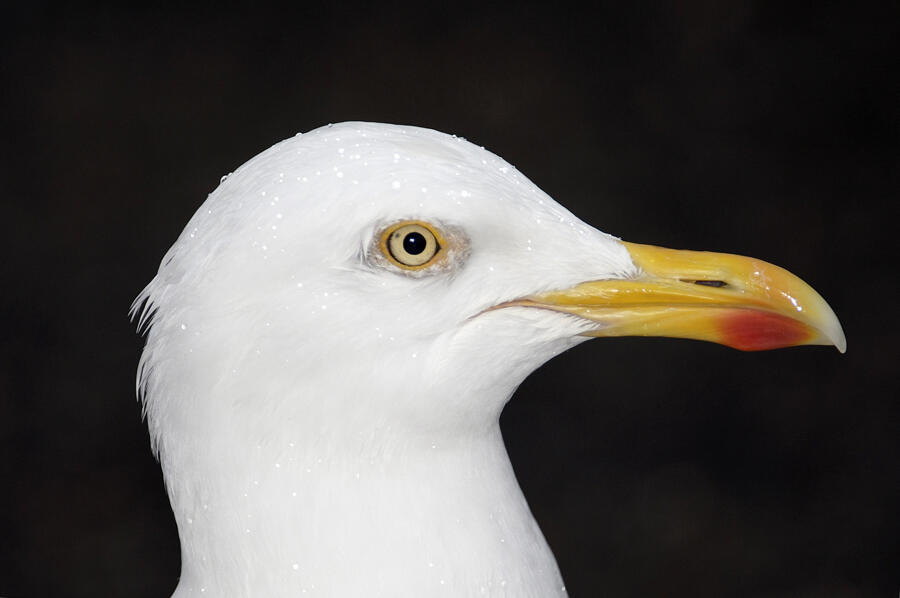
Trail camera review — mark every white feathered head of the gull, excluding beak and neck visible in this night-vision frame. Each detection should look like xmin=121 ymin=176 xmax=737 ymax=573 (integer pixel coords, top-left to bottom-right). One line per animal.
xmin=139 ymin=123 xmax=639 ymax=450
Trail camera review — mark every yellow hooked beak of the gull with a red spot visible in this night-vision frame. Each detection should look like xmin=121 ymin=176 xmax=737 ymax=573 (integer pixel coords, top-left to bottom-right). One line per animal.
xmin=514 ymin=243 xmax=847 ymax=353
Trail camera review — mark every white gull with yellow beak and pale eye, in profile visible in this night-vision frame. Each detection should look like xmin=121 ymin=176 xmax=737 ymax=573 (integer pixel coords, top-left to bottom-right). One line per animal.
xmin=132 ymin=122 xmax=846 ymax=598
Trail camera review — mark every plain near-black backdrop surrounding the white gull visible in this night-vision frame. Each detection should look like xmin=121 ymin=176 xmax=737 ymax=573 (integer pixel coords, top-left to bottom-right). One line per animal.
xmin=0 ymin=0 xmax=900 ymax=598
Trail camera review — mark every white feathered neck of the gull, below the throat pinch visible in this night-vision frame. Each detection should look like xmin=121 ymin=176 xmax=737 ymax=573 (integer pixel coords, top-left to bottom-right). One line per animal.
xmin=163 ymin=425 xmax=565 ymax=598
